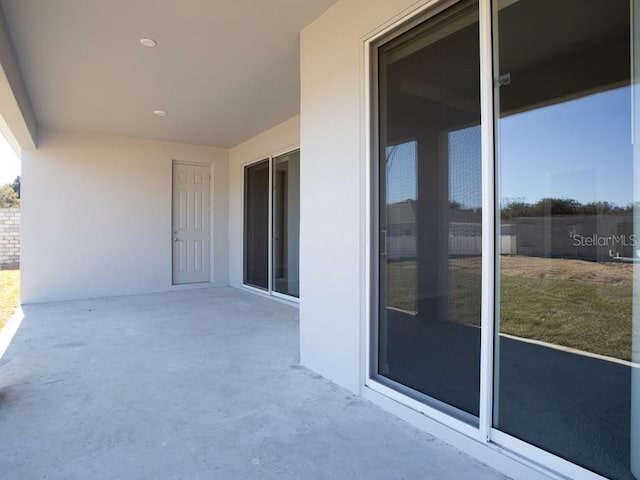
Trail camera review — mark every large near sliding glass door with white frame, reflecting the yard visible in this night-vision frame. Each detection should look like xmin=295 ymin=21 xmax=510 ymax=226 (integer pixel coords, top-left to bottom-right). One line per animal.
xmin=370 ymin=0 xmax=640 ymax=480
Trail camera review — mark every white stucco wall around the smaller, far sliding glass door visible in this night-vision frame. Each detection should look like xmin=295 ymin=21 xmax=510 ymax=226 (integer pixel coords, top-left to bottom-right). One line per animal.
xmin=229 ymin=116 xmax=304 ymax=287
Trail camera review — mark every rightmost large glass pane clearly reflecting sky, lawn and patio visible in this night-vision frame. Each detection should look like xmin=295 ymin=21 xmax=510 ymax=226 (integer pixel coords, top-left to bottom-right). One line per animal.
xmin=494 ymin=0 xmax=640 ymax=479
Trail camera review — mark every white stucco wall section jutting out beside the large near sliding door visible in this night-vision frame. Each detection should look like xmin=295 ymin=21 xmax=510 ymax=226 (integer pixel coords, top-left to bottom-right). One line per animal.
xmin=300 ymin=0 xmax=415 ymax=392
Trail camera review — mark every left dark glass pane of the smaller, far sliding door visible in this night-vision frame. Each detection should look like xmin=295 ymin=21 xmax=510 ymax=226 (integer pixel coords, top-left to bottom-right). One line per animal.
xmin=244 ymin=160 xmax=269 ymax=289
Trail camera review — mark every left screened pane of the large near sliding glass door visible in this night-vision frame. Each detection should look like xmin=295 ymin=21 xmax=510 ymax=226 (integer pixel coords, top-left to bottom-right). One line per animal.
xmin=378 ymin=2 xmax=482 ymax=424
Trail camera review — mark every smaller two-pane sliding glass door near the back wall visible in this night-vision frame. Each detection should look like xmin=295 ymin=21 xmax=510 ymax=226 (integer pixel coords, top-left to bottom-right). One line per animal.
xmin=244 ymin=150 xmax=300 ymax=298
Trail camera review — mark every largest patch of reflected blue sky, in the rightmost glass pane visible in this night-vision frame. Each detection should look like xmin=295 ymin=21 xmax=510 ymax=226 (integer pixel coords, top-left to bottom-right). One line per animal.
xmin=499 ymin=87 xmax=633 ymax=205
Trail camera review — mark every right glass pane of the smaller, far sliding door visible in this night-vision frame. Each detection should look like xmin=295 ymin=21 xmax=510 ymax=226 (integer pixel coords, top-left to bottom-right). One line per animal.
xmin=273 ymin=150 xmax=300 ymax=297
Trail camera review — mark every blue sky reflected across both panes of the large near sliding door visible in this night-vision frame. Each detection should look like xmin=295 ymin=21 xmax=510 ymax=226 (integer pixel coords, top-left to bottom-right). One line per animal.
xmin=387 ymin=87 xmax=633 ymax=208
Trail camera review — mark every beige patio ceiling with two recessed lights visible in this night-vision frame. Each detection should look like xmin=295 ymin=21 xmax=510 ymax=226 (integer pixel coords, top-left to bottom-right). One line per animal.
xmin=0 ymin=0 xmax=336 ymax=147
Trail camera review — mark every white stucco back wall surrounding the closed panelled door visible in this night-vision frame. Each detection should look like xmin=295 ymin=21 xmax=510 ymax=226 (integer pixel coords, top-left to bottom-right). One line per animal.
xmin=21 ymin=130 xmax=228 ymax=303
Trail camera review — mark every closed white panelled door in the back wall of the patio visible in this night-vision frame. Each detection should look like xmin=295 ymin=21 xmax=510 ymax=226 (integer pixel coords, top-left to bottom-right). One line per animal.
xmin=172 ymin=163 xmax=211 ymax=284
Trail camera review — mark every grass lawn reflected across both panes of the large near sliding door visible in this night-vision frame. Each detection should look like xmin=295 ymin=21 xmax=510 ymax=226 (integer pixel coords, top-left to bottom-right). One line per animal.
xmin=387 ymin=256 xmax=633 ymax=360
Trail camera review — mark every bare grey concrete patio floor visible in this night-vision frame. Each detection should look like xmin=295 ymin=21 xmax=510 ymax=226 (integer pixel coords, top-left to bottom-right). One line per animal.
xmin=0 ymin=288 xmax=505 ymax=480
